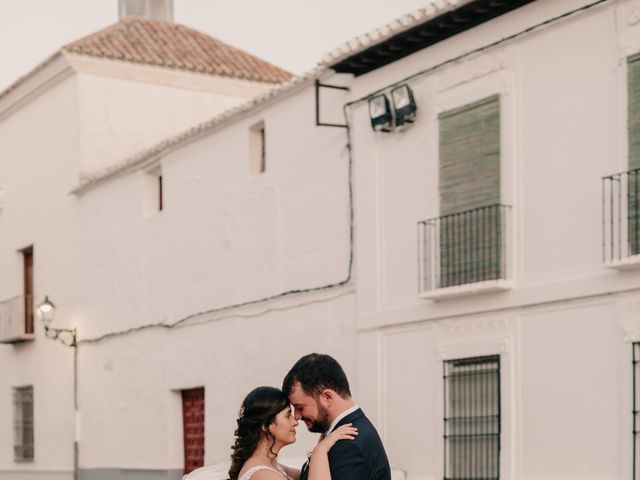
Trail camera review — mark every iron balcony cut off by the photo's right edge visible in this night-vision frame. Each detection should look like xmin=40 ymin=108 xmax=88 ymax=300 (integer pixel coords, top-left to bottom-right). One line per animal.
xmin=602 ymin=168 xmax=640 ymax=269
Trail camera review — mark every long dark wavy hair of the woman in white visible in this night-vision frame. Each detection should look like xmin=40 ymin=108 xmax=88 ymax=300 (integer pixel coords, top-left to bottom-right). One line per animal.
xmin=229 ymin=387 xmax=290 ymax=480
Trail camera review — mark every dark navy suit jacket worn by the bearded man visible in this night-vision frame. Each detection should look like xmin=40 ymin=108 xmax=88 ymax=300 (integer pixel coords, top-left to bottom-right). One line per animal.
xmin=300 ymin=409 xmax=391 ymax=480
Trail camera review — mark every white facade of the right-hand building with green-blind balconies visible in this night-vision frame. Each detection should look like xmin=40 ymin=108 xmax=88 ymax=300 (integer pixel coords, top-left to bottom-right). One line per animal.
xmin=336 ymin=1 xmax=640 ymax=479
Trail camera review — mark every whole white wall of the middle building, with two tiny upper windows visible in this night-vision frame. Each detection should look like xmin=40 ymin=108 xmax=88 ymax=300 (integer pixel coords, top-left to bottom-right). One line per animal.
xmin=71 ymin=82 xmax=357 ymax=471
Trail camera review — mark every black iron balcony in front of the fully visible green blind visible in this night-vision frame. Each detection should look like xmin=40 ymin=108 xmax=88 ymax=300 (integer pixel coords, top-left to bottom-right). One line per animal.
xmin=418 ymin=204 xmax=511 ymax=300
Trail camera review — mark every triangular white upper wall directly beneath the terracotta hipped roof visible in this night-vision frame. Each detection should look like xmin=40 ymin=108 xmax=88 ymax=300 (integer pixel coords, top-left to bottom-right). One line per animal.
xmin=78 ymin=71 xmax=269 ymax=175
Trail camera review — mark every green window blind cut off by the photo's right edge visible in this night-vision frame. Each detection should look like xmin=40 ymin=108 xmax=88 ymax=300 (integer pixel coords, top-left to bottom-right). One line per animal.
xmin=627 ymin=55 xmax=640 ymax=255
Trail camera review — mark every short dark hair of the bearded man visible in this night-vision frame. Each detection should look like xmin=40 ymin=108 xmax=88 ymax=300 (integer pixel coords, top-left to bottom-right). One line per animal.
xmin=282 ymin=353 xmax=351 ymax=398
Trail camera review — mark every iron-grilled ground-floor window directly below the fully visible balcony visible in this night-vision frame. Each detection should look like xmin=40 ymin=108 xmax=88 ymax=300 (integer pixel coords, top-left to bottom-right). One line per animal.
xmin=444 ymin=355 xmax=500 ymax=480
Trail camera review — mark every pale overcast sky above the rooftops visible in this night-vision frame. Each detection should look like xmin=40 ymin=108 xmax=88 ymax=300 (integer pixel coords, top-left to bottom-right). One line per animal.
xmin=0 ymin=0 xmax=431 ymax=90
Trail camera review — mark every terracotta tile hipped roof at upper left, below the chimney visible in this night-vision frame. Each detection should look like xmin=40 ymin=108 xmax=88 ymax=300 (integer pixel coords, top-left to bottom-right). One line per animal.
xmin=63 ymin=17 xmax=291 ymax=83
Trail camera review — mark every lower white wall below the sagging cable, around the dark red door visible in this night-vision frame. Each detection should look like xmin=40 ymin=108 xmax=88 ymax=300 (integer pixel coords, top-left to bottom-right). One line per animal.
xmin=80 ymin=291 xmax=356 ymax=470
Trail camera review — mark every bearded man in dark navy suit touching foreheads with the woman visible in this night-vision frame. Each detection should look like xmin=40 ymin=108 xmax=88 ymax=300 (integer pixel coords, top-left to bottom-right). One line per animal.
xmin=282 ymin=353 xmax=391 ymax=480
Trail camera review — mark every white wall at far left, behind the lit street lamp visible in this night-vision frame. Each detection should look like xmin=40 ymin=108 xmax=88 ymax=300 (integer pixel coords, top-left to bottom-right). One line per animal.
xmin=0 ymin=78 xmax=78 ymax=478
